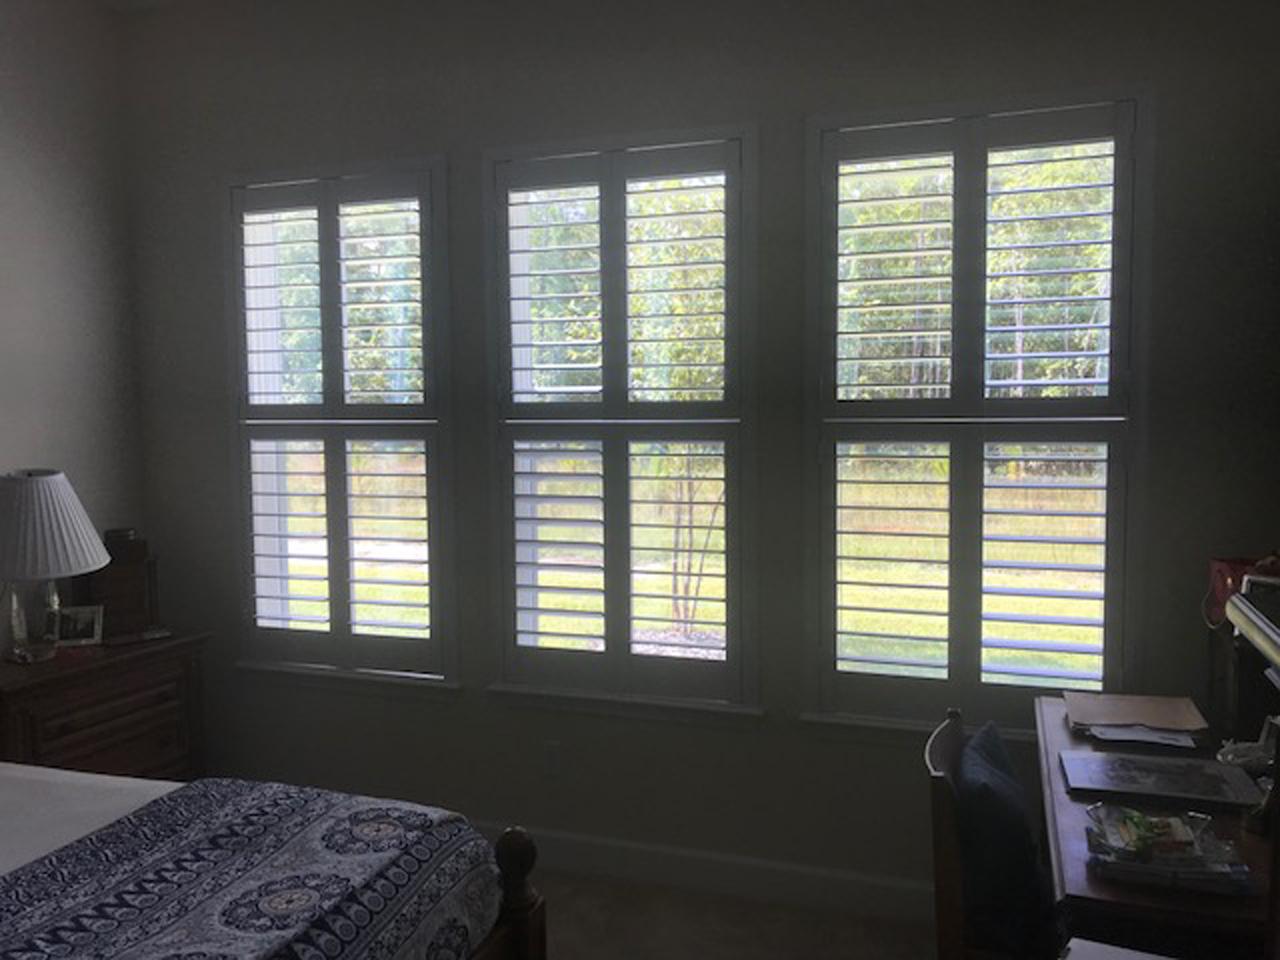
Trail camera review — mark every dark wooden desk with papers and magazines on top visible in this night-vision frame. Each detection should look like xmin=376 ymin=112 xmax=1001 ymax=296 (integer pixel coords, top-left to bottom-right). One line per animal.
xmin=1036 ymin=696 xmax=1271 ymax=960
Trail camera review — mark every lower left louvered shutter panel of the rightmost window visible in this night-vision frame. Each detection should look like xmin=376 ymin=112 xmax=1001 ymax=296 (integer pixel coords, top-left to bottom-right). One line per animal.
xmin=836 ymin=443 xmax=951 ymax=680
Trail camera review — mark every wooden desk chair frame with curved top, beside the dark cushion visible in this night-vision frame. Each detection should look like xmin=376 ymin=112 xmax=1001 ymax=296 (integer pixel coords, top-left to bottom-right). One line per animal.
xmin=924 ymin=708 xmax=1172 ymax=960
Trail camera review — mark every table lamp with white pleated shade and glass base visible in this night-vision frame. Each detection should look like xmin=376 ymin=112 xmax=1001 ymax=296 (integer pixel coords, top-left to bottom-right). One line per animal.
xmin=0 ymin=470 xmax=111 ymax=663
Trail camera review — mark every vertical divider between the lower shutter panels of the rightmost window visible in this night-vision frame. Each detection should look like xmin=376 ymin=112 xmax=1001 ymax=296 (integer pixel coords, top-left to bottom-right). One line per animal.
xmin=948 ymin=426 xmax=982 ymax=690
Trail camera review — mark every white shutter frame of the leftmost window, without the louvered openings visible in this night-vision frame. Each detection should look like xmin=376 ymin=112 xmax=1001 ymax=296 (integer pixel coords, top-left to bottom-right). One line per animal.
xmin=223 ymin=156 xmax=458 ymax=684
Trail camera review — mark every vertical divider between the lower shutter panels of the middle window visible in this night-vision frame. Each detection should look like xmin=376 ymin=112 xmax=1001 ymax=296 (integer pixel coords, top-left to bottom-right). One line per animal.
xmin=604 ymin=430 xmax=631 ymax=690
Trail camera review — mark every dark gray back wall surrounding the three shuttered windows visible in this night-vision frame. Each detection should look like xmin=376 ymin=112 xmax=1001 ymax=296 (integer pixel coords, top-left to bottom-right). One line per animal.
xmin=115 ymin=0 xmax=1280 ymax=904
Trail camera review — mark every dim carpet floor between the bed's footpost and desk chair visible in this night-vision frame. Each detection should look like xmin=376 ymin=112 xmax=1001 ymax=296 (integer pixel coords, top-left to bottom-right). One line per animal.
xmin=535 ymin=870 xmax=933 ymax=960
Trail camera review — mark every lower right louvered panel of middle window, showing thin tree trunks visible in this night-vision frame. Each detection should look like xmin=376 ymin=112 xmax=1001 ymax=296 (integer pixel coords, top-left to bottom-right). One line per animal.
xmin=628 ymin=440 xmax=727 ymax=660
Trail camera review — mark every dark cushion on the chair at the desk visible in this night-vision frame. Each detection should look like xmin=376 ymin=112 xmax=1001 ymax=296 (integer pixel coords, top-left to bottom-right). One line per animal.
xmin=955 ymin=723 xmax=1059 ymax=960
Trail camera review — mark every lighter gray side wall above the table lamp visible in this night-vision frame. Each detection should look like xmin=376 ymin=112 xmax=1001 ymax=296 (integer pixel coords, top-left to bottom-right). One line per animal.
xmin=0 ymin=0 xmax=142 ymax=527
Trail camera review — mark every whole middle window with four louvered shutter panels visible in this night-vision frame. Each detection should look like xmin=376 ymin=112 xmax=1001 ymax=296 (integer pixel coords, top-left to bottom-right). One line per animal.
xmin=494 ymin=140 xmax=744 ymax=700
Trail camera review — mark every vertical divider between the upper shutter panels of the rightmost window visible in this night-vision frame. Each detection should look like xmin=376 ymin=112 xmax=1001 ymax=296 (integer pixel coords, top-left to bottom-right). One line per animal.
xmin=951 ymin=120 xmax=987 ymax=412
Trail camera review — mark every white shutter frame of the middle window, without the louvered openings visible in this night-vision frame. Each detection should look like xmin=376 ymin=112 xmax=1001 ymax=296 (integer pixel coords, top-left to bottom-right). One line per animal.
xmin=483 ymin=127 xmax=758 ymax=707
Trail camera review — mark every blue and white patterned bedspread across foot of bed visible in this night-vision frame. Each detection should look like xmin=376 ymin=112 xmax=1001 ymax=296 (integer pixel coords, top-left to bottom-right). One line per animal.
xmin=0 ymin=780 xmax=502 ymax=960
